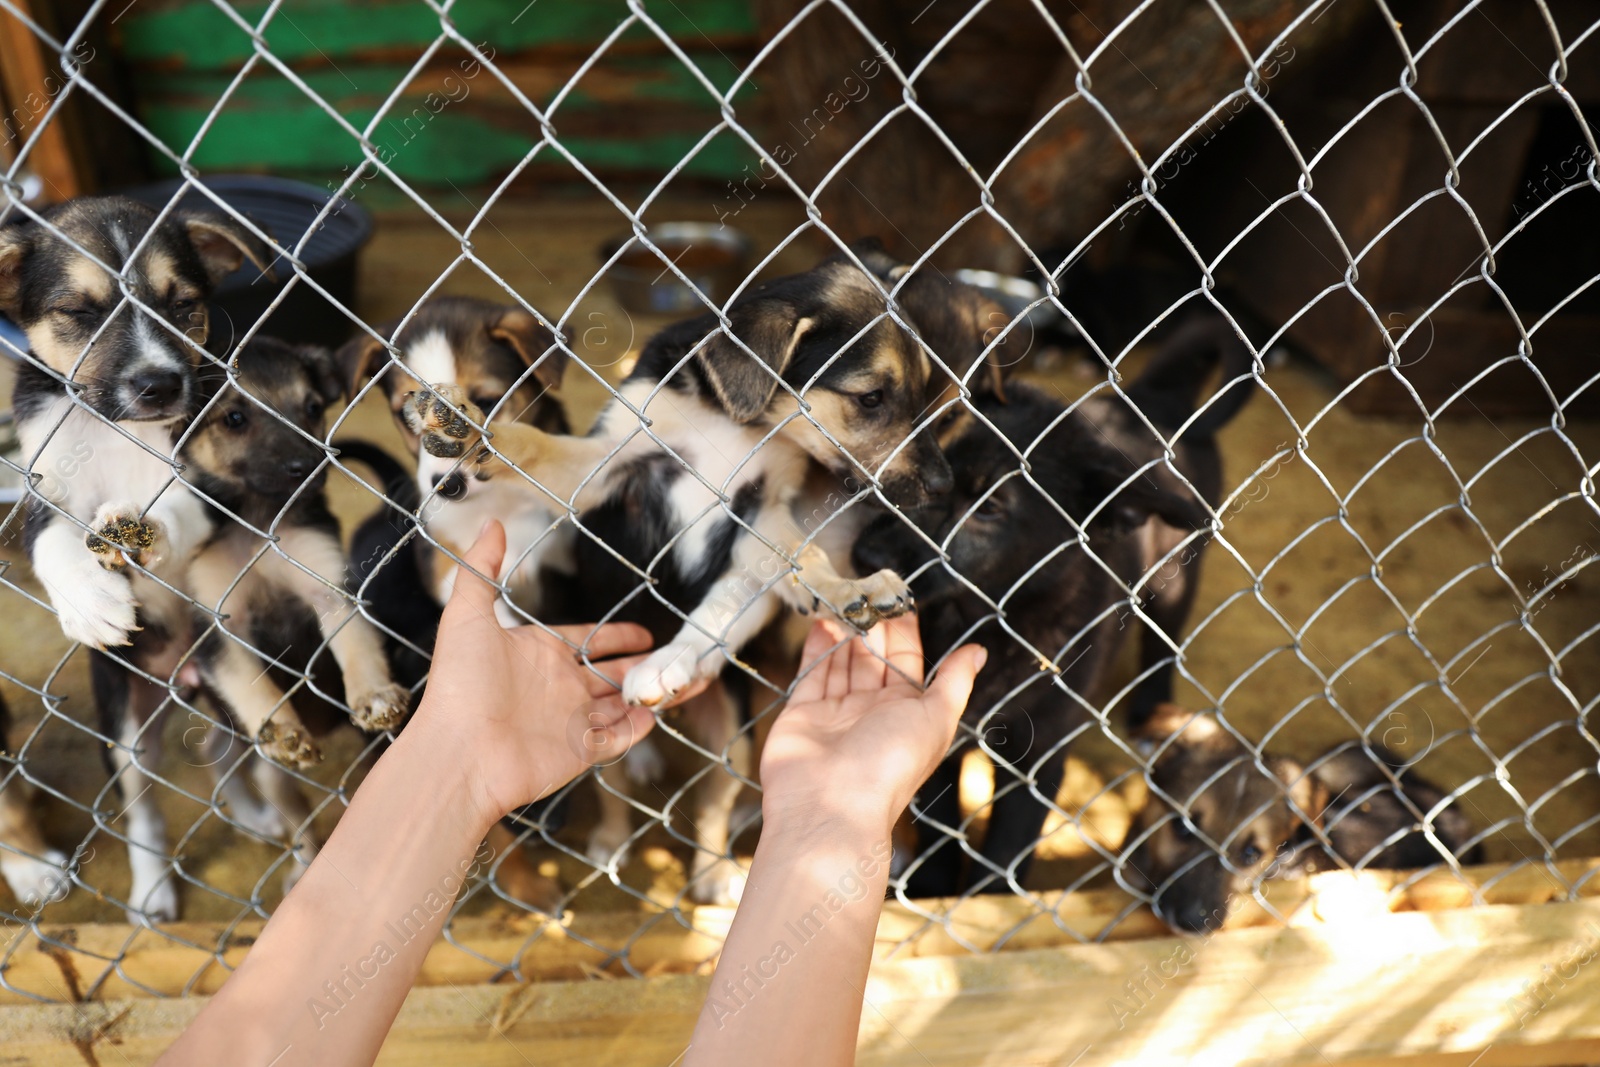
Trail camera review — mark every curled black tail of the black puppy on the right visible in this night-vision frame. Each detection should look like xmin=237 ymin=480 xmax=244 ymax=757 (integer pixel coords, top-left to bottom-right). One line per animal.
xmin=1128 ymin=315 xmax=1256 ymax=442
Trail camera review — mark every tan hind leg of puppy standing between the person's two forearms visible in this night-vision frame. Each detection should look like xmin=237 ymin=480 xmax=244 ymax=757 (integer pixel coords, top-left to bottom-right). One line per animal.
xmin=683 ymin=683 xmax=750 ymax=905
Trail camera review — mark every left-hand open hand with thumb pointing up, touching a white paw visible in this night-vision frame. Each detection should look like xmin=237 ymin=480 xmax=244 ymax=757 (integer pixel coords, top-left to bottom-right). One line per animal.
xmin=406 ymin=520 xmax=668 ymax=825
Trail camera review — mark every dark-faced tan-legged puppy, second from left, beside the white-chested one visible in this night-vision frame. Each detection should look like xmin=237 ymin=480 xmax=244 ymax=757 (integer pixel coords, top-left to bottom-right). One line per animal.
xmin=182 ymin=338 xmax=410 ymax=889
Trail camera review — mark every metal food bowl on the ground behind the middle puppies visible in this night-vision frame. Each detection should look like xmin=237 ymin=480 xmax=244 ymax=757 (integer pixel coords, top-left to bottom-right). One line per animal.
xmin=600 ymin=222 xmax=750 ymax=315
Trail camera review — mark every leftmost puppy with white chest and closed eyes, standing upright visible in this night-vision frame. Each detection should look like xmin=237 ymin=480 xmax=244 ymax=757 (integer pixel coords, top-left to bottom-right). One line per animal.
xmin=0 ymin=197 xmax=269 ymax=920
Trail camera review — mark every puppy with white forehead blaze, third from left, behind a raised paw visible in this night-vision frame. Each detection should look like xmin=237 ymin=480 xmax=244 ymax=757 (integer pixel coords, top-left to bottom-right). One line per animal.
xmin=338 ymin=296 xmax=573 ymax=633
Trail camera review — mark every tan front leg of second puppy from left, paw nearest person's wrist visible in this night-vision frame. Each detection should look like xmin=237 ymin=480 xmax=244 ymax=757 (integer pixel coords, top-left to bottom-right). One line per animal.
xmin=277 ymin=528 xmax=411 ymax=733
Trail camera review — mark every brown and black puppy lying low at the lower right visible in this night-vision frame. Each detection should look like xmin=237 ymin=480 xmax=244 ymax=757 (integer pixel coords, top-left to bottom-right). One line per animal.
xmin=1125 ymin=704 xmax=1482 ymax=933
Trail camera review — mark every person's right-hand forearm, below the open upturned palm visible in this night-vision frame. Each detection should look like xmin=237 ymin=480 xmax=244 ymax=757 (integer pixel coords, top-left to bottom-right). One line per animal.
xmin=685 ymin=813 xmax=891 ymax=1067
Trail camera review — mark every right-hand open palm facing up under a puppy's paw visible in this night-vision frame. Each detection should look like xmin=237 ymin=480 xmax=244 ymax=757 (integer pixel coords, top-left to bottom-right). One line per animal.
xmin=762 ymin=614 xmax=989 ymax=837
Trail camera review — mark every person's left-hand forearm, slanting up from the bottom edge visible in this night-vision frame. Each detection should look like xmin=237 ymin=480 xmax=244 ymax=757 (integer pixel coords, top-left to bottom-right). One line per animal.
xmin=162 ymin=709 xmax=488 ymax=1067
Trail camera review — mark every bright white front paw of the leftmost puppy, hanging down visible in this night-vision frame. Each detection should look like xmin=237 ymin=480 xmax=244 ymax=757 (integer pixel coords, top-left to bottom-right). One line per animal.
xmin=32 ymin=517 xmax=139 ymax=648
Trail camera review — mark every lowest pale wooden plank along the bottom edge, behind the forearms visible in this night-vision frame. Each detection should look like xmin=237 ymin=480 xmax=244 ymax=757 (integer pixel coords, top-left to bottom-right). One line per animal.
xmin=9 ymin=901 xmax=1600 ymax=1067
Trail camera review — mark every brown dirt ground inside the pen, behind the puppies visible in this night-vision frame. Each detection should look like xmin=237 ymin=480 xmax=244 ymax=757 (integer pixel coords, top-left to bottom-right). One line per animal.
xmin=0 ymin=198 xmax=1600 ymax=940
